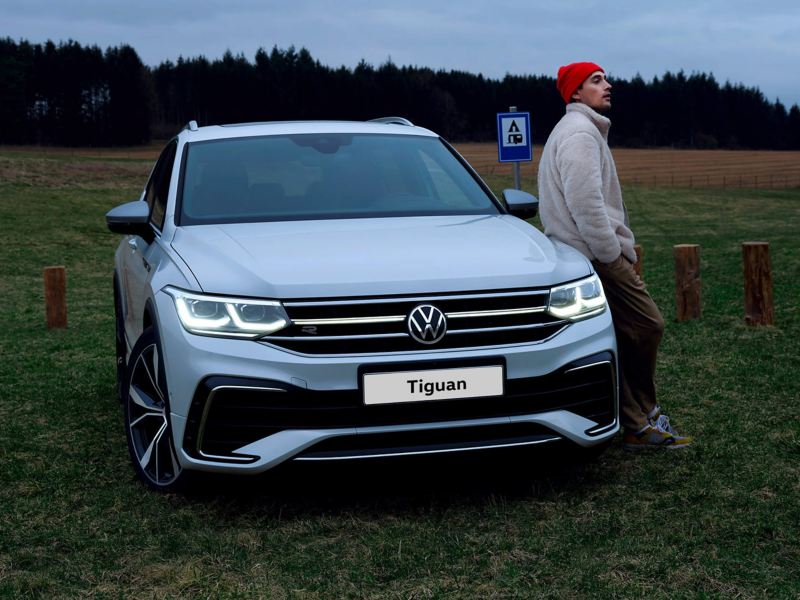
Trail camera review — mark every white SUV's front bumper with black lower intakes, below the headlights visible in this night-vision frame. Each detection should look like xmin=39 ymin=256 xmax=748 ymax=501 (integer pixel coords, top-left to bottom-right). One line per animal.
xmin=157 ymin=294 xmax=619 ymax=473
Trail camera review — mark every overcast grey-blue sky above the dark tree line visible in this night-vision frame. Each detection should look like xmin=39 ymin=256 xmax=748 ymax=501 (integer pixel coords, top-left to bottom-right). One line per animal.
xmin=0 ymin=0 xmax=800 ymax=108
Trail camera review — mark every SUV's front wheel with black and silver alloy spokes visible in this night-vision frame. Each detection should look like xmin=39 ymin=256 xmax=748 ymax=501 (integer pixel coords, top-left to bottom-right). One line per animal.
xmin=122 ymin=327 xmax=189 ymax=492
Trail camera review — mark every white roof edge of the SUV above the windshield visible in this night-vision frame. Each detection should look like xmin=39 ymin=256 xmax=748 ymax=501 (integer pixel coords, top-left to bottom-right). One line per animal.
xmin=179 ymin=121 xmax=438 ymax=142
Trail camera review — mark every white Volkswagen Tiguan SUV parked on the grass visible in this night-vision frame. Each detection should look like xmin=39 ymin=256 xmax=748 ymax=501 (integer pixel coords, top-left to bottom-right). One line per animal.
xmin=107 ymin=118 xmax=619 ymax=490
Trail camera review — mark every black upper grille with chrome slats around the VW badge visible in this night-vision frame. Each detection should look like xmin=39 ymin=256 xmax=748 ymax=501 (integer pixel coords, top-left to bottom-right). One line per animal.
xmin=261 ymin=289 xmax=568 ymax=354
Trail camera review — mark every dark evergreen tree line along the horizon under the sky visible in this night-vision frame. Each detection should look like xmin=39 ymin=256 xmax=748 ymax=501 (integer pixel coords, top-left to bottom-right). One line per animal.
xmin=0 ymin=38 xmax=800 ymax=150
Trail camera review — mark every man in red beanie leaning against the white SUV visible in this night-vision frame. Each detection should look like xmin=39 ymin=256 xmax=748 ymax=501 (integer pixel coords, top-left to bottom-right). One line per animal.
xmin=539 ymin=62 xmax=692 ymax=450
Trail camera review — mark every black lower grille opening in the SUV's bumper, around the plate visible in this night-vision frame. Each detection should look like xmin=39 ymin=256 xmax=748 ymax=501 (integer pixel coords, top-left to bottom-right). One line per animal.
xmin=184 ymin=353 xmax=616 ymax=460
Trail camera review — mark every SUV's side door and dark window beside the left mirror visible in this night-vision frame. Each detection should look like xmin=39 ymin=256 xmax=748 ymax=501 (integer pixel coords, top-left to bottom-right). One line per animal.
xmin=123 ymin=140 xmax=178 ymax=343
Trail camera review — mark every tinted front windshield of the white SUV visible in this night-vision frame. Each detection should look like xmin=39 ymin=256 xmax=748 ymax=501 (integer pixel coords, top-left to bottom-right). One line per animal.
xmin=179 ymin=133 xmax=500 ymax=225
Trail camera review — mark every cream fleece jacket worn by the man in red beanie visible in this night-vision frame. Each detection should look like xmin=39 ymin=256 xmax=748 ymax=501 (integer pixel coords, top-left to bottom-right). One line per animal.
xmin=539 ymin=102 xmax=636 ymax=263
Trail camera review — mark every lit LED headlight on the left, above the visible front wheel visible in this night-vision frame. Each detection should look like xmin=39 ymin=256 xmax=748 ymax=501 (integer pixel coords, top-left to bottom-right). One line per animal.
xmin=164 ymin=287 xmax=291 ymax=338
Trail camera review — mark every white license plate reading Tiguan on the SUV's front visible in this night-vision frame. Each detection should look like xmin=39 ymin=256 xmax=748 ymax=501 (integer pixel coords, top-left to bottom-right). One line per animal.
xmin=364 ymin=366 xmax=503 ymax=404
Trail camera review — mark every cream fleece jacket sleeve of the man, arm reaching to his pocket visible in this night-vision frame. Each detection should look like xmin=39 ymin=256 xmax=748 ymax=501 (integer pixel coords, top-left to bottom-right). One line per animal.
xmin=556 ymin=132 xmax=622 ymax=263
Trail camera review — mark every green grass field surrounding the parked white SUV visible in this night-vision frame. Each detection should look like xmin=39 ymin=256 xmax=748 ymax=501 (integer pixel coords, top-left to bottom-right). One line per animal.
xmin=0 ymin=150 xmax=800 ymax=598
